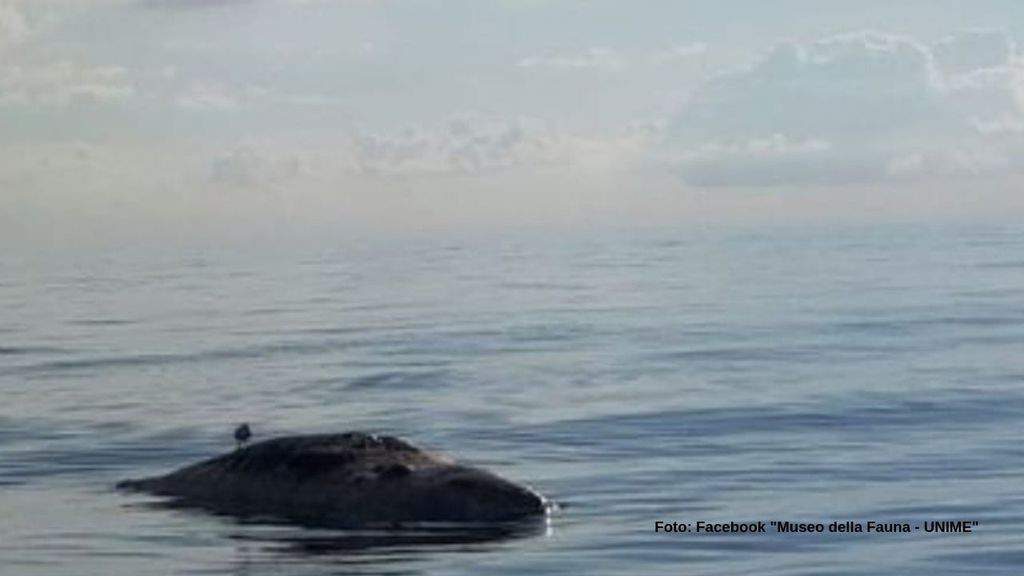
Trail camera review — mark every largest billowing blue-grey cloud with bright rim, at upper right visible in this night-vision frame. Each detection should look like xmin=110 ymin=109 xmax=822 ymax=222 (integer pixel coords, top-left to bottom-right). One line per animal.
xmin=666 ymin=31 xmax=1024 ymax=186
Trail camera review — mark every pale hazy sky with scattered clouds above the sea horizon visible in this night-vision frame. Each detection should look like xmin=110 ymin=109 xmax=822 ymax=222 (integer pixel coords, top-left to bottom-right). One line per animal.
xmin=0 ymin=0 xmax=1024 ymax=250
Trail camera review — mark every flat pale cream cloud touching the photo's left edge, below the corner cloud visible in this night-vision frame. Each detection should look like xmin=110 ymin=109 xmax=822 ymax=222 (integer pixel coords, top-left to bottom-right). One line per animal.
xmin=0 ymin=60 xmax=135 ymax=106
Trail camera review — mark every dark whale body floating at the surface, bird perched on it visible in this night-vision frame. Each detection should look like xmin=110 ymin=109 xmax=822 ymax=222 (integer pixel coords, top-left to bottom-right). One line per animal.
xmin=118 ymin=431 xmax=548 ymax=527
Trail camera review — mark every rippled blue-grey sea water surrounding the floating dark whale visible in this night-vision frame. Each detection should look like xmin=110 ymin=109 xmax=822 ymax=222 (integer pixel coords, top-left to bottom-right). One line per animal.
xmin=0 ymin=225 xmax=1024 ymax=576
